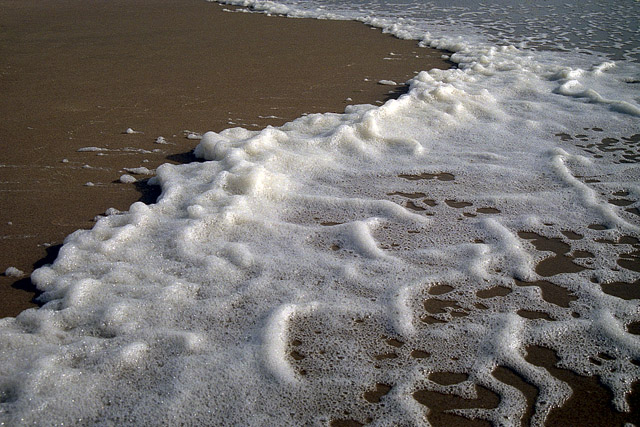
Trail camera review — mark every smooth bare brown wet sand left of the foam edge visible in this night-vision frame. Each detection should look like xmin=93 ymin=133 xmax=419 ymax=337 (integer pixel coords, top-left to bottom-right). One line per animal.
xmin=0 ymin=0 xmax=450 ymax=317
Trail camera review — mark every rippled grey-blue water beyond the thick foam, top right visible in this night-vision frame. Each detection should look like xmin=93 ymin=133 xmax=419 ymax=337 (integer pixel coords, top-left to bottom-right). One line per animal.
xmin=251 ymin=0 xmax=640 ymax=62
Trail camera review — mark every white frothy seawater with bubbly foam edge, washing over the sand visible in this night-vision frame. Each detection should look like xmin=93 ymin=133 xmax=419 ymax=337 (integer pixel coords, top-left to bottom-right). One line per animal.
xmin=0 ymin=2 xmax=640 ymax=425
